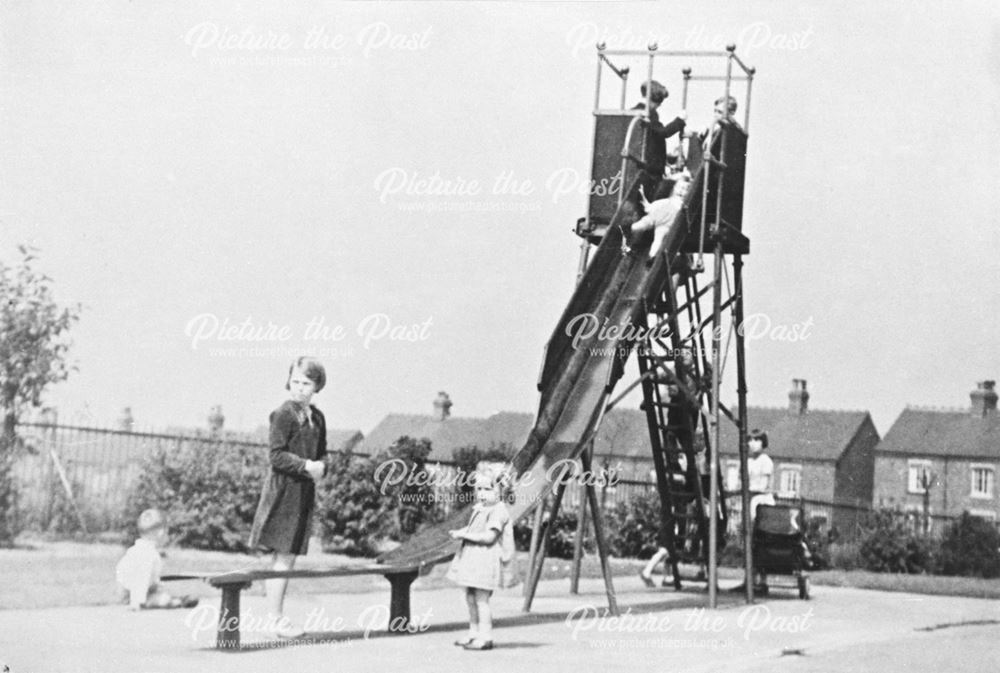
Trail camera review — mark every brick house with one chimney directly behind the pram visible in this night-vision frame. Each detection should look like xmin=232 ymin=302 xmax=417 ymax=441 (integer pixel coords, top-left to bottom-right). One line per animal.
xmin=720 ymin=379 xmax=879 ymax=534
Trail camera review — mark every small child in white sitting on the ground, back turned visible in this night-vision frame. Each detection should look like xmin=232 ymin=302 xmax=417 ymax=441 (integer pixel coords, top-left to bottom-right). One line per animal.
xmin=115 ymin=509 xmax=198 ymax=610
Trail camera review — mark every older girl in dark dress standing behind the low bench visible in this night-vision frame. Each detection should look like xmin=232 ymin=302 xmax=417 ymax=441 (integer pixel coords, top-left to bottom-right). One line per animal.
xmin=250 ymin=357 xmax=326 ymax=638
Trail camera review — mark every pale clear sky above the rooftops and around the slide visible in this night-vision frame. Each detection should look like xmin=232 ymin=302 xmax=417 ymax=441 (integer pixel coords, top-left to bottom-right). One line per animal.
xmin=0 ymin=1 xmax=1000 ymax=434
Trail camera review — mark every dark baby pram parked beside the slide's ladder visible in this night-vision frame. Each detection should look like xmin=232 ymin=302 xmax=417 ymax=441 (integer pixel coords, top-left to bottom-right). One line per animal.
xmin=753 ymin=505 xmax=810 ymax=600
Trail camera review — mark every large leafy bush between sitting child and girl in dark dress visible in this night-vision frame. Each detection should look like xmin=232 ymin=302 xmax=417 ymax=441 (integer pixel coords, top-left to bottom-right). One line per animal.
xmin=126 ymin=439 xmax=267 ymax=551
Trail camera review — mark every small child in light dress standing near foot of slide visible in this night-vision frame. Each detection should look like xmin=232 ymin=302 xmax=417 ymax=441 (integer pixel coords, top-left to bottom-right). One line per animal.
xmin=447 ymin=464 xmax=514 ymax=650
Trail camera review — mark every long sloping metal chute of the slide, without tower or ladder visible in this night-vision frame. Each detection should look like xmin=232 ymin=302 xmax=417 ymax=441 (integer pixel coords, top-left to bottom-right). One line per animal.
xmin=378 ymin=148 xmax=720 ymax=565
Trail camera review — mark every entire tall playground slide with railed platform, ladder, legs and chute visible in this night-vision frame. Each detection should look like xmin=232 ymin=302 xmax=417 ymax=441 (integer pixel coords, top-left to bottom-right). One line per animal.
xmin=379 ymin=44 xmax=754 ymax=613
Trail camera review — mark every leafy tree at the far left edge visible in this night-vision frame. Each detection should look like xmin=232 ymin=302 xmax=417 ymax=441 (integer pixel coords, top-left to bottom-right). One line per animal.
xmin=0 ymin=245 xmax=80 ymax=546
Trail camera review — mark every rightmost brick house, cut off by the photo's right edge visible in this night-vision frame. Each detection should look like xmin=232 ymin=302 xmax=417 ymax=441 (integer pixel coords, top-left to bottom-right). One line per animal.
xmin=873 ymin=381 xmax=1000 ymax=529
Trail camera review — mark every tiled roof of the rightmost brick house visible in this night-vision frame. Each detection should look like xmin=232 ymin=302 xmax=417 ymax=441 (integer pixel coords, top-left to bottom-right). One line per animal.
xmin=876 ymin=407 xmax=1000 ymax=460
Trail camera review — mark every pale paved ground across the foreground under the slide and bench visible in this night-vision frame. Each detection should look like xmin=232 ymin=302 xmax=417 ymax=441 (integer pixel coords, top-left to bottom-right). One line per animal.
xmin=0 ymin=578 xmax=1000 ymax=673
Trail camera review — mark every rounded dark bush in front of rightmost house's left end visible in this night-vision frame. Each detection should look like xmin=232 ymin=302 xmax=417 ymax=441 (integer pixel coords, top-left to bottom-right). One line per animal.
xmin=859 ymin=510 xmax=934 ymax=574
